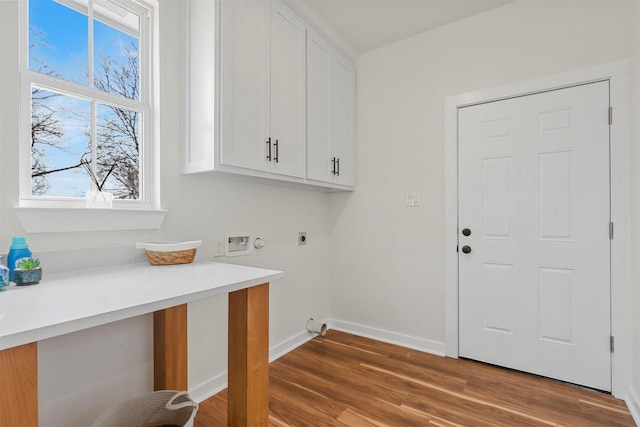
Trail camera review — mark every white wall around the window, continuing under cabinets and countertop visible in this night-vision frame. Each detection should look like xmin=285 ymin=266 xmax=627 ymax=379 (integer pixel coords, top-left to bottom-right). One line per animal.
xmin=0 ymin=1 xmax=330 ymax=427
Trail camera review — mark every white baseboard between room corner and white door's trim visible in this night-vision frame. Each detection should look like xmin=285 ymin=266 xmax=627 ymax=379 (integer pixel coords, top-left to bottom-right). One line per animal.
xmin=328 ymin=319 xmax=444 ymax=356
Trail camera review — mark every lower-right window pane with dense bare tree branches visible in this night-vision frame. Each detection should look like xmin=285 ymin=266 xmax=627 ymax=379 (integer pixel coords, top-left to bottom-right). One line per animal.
xmin=96 ymin=104 xmax=141 ymax=200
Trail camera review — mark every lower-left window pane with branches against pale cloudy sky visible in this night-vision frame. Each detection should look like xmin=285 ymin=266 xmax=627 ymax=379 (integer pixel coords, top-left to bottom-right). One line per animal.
xmin=31 ymin=86 xmax=91 ymax=197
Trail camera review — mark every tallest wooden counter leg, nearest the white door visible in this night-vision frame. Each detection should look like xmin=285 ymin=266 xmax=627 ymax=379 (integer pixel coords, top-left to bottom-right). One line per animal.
xmin=228 ymin=283 xmax=269 ymax=427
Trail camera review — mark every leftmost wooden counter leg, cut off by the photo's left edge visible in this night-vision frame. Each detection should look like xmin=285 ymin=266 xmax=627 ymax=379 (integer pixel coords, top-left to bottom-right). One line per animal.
xmin=0 ymin=342 xmax=38 ymax=427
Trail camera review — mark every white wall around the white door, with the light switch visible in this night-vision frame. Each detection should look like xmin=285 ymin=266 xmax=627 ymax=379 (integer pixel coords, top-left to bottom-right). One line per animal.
xmin=331 ymin=1 xmax=640 ymax=396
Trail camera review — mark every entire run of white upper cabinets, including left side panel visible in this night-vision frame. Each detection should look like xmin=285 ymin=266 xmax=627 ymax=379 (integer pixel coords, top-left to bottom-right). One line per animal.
xmin=183 ymin=0 xmax=355 ymax=190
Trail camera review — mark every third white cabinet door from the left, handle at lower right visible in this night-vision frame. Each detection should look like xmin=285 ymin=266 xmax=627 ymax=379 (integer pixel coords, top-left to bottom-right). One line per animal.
xmin=307 ymin=30 xmax=334 ymax=183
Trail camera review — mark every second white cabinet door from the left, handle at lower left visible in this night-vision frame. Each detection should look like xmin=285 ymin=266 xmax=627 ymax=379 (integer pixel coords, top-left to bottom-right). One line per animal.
xmin=271 ymin=0 xmax=306 ymax=178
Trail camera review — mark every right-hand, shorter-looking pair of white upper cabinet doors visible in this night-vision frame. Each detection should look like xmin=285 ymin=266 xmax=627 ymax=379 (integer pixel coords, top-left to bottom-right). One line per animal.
xmin=307 ymin=30 xmax=355 ymax=187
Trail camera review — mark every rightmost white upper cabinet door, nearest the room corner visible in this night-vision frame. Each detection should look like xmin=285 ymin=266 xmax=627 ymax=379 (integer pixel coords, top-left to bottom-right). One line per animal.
xmin=332 ymin=52 xmax=356 ymax=186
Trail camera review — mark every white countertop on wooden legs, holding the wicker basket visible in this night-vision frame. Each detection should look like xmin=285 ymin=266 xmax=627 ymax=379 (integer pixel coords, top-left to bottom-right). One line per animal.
xmin=0 ymin=261 xmax=284 ymax=350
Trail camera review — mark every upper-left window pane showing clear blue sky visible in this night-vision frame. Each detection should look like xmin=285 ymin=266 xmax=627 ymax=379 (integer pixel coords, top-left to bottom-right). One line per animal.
xmin=29 ymin=0 xmax=88 ymax=85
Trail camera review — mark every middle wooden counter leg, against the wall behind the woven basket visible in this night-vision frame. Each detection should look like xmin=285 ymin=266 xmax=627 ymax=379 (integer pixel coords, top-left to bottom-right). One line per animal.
xmin=153 ymin=304 xmax=189 ymax=390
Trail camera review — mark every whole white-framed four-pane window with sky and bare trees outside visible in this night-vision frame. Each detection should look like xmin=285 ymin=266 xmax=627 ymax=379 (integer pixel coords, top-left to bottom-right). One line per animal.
xmin=20 ymin=0 xmax=159 ymax=209
